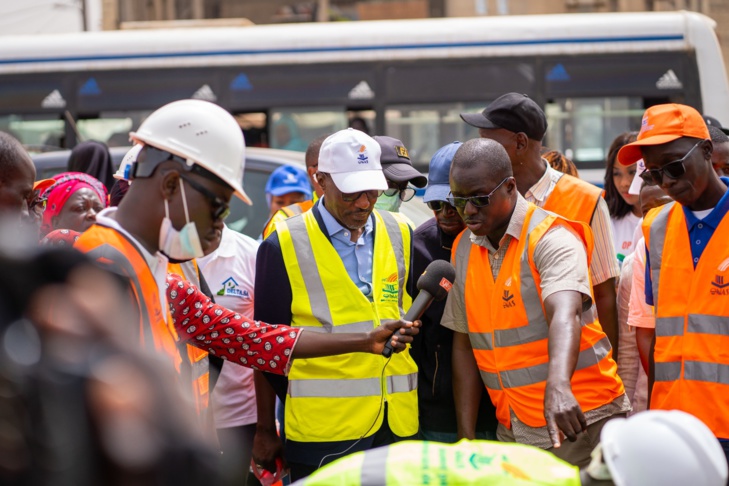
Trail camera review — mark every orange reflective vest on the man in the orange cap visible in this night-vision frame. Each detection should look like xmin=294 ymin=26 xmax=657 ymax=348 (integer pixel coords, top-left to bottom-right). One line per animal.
xmin=643 ymin=203 xmax=729 ymax=438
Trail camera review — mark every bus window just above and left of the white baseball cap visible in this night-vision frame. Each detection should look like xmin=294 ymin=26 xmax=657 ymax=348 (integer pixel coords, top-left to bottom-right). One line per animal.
xmin=268 ymin=108 xmax=349 ymax=152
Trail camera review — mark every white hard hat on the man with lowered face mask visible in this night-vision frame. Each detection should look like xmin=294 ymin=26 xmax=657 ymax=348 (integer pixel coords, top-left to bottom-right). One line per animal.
xmin=129 ymin=100 xmax=251 ymax=204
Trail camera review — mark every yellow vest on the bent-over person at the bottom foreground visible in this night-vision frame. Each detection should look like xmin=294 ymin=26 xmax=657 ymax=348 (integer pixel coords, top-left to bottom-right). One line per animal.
xmin=297 ymin=439 xmax=581 ymax=486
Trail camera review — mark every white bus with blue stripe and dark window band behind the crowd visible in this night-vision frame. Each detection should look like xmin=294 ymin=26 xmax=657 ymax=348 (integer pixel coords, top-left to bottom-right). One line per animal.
xmin=0 ymin=11 xmax=729 ymax=179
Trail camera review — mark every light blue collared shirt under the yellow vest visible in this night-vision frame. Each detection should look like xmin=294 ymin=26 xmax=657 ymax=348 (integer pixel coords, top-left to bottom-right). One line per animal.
xmin=316 ymin=197 xmax=375 ymax=300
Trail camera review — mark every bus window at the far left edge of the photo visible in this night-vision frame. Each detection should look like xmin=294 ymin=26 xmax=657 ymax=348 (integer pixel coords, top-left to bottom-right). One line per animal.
xmin=0 ymin=115 xmax=64 ymax=152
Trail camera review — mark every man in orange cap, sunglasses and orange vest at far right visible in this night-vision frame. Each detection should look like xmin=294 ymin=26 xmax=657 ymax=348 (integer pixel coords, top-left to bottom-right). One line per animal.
xmin=618 ymin=104 xmax=729 ymax=464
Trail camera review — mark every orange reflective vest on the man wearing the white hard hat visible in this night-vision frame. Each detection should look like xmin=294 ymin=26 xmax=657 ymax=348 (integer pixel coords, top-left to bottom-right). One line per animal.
xmin=74 ymin=223 xmax=182 ymax=372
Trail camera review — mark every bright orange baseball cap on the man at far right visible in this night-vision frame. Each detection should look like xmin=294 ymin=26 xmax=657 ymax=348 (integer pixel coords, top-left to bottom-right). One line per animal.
xmin=618 ymin=103 xmax=711 ymax=165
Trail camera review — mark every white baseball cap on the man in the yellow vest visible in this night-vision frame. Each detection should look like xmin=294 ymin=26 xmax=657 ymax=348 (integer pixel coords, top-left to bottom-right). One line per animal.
xmin=318 ymin=128 xmax=387 ymax=193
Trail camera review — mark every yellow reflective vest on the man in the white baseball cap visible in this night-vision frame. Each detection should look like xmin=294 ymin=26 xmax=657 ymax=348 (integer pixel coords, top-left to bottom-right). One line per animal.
xmin=276 ymin=210 xmax=418 ymax=442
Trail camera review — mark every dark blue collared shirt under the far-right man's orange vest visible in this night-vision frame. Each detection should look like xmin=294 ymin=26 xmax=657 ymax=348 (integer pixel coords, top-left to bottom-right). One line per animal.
xmin=645 ymin=177 xmax=729 ymax=305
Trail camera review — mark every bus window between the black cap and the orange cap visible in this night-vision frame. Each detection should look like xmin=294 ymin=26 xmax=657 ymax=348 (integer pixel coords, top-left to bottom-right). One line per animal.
xmin=544 ymin=97 xmax=644 ymax=174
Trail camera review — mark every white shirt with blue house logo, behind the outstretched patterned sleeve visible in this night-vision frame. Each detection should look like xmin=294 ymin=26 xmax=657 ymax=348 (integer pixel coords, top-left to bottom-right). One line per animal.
xmin=197 ymin=226 xmax=258 ymax=429
